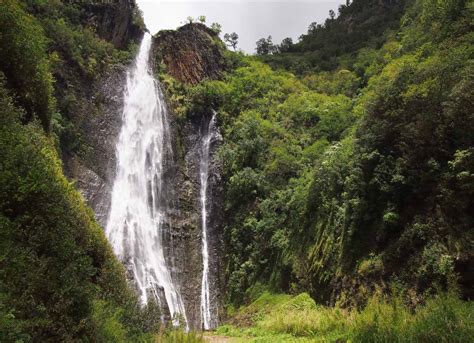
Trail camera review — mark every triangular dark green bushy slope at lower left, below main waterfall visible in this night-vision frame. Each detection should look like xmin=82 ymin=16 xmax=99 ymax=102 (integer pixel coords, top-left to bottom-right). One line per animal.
xmin=0 ymin=80 xmax=154 ymax=341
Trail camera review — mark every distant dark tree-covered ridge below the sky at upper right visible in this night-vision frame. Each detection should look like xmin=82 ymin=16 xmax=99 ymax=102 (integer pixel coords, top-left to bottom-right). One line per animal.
xmin=261 ymin=0 xmax=412 ymax=74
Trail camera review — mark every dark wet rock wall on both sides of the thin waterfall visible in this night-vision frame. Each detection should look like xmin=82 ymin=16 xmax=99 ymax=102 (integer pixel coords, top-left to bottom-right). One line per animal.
xmin=166 ymin=116 xmax=224 ymax=329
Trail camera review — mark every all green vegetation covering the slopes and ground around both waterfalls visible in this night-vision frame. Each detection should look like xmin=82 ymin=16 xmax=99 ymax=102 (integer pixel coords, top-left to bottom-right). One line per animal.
xmin=0 ymin=0 xmax=474 ymax=342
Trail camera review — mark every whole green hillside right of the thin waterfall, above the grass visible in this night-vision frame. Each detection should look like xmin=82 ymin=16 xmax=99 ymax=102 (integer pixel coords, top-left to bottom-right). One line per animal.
xmin=168 ymin=0 xmax=474 ymax=314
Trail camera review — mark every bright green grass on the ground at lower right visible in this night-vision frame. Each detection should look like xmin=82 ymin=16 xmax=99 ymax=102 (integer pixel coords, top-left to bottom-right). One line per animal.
xmin=216 ymin=293 xmax=474 ymax=342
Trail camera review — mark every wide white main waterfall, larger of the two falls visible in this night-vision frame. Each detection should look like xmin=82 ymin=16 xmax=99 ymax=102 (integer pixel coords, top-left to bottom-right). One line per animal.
xmin=106 ymin=34 xmax=187 ymax=326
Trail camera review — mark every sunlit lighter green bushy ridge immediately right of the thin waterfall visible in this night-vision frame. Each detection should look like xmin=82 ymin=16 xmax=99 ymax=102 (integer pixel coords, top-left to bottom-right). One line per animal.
xmin=182 ymin=58 xmax=360 ymax=303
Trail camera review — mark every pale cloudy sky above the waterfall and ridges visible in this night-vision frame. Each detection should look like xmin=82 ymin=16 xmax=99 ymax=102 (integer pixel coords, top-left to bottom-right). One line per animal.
xmin=137 ymin=0 xmax=345 ymax=54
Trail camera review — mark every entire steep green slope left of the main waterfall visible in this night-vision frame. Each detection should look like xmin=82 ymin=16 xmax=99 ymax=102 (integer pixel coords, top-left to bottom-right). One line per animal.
xmin=0 ymin=0 xmax=157 ymax=342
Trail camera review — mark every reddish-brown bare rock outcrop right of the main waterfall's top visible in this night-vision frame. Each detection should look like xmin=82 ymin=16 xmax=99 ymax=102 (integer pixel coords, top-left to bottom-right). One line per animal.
xmin=154 ymin=23 xmax=224 ymax=84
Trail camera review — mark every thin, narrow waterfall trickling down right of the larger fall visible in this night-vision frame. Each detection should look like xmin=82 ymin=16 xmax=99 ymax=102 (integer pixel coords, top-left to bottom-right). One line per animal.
xmin=199 ymin=113 xmax=215 ymax=330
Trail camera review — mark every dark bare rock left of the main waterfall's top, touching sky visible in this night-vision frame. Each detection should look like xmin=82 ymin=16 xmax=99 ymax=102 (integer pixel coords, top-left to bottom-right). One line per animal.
xmin=82 ymin=0 xmax=144 ymax=48
